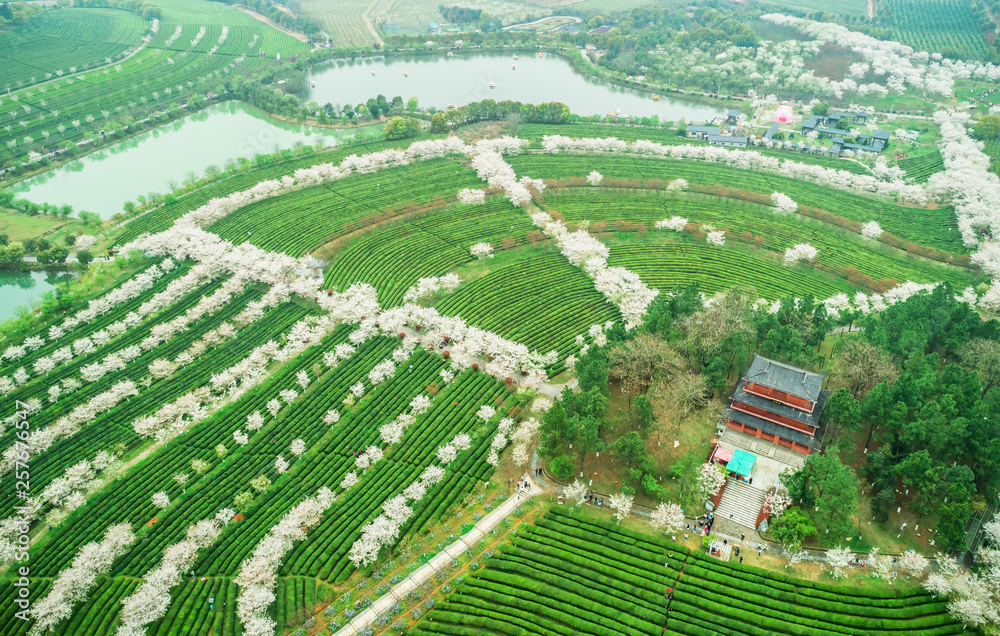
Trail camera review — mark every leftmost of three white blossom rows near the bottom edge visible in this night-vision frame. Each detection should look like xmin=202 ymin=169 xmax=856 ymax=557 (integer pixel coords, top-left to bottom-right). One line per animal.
xmin=28 ymin=523 xmax=135 ymax=636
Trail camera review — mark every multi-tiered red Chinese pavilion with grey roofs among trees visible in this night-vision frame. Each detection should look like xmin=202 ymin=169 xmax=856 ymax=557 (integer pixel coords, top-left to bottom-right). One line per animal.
xmin=726 ymin=356 xmax=829 ymax=455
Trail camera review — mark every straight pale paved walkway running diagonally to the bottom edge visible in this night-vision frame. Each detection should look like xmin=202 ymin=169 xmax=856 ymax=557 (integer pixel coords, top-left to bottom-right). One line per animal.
xmin=335 ymin=476 xmax=542 ymax=636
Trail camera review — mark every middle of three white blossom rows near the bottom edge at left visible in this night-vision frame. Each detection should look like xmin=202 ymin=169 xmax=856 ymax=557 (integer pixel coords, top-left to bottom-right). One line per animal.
xmin=115 ymin=508 xmax=236 ymax=636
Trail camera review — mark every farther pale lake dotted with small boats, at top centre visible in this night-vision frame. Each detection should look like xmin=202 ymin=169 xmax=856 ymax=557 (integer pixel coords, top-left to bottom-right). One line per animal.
xmin=308 ymin=53 xmax=725 ymax=122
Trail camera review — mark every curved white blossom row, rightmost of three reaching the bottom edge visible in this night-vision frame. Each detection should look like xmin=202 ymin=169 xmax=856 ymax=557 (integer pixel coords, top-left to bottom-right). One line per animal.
xmin=235 ymin=487 xmax=334 ymax=636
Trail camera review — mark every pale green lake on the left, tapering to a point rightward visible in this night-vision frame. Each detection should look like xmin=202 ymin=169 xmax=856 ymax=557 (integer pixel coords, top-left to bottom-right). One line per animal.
xmin=11 ymin=102 xmax=383 ymax=219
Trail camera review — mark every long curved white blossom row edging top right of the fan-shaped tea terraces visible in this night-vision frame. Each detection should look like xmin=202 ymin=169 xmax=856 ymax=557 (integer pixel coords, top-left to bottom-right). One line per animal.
xmin=542 ymin=135 xmax=929 ymax=204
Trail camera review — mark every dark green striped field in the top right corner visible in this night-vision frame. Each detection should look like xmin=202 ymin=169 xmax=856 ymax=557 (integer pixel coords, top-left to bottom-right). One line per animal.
xmin=886 ymin=0 xmax=987 ymax=59
